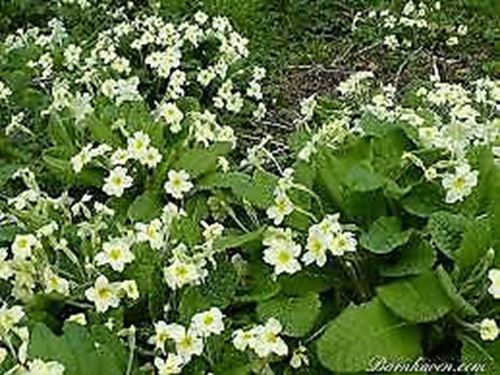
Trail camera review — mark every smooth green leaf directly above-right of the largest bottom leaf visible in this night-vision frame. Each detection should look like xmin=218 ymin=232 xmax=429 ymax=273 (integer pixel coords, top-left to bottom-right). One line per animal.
xmin=377 ymin=272 xmax=453 ymax=323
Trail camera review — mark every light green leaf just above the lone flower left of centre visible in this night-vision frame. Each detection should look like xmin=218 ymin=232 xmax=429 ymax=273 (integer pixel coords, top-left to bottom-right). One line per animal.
xmin=173 ymin=143 xmax=231 ymax=177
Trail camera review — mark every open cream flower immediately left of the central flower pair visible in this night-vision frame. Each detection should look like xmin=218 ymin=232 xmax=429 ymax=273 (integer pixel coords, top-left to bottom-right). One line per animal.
xmin=264 ymin=241 xmax=301 ymax=275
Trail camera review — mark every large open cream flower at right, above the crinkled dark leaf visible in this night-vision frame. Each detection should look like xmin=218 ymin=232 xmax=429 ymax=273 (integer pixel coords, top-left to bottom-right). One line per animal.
xmin=442 ymin=164 xmax=478 ymax=203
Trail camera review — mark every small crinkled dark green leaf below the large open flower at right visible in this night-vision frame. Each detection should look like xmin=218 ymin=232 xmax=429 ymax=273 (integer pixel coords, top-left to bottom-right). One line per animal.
xmin=427 ymin=211 xmax=467 ymax=258
